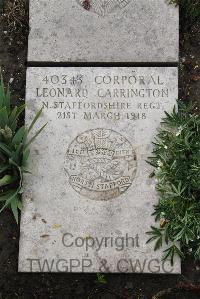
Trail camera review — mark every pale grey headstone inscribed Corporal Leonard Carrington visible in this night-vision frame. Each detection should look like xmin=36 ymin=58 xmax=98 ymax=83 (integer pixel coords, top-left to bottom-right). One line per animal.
xmin=19 ymin=67 xmax=180 ymax=273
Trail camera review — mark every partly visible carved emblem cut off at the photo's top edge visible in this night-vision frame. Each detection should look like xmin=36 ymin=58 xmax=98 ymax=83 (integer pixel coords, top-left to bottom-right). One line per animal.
xmin=76 ymin=0 xmax=132 ymax=17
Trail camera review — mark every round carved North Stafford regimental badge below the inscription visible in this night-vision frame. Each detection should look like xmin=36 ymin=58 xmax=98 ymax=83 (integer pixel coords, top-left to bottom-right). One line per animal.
xmin=65 ymin=128 xmax=137 ymax=200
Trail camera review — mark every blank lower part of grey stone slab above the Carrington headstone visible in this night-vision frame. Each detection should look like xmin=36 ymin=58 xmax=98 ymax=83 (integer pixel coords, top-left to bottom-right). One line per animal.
xmin=28 ymin=0 xmax=179 ymax=62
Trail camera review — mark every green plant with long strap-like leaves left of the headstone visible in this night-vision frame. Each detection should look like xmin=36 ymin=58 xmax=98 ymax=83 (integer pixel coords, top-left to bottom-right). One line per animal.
xmin=0 ymin=76 xmax=46 ymax=223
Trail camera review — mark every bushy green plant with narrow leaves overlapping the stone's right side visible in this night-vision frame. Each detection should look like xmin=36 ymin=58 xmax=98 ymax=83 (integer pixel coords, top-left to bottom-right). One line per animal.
xmin=147 ymin=102 xmax=200 ymax=263
